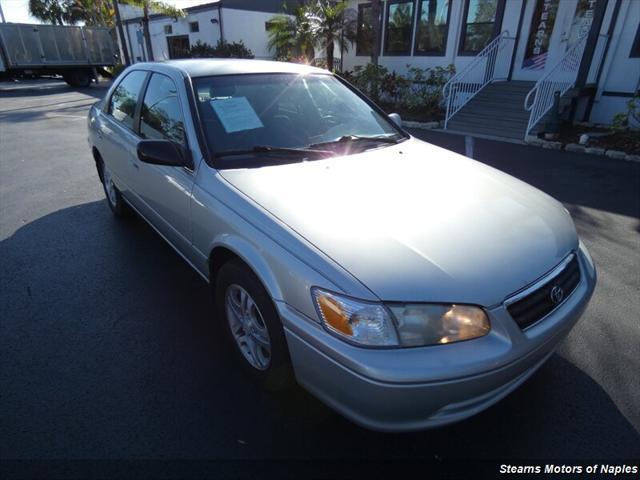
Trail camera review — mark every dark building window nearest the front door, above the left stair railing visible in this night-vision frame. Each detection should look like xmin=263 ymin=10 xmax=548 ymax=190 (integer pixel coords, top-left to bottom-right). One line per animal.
xmin=460 ymin=0 xmax=504 ymax=55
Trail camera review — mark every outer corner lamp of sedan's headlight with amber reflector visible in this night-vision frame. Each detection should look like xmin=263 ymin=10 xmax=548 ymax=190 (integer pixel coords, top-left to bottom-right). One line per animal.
xmin=311 ymin=288 xmax=399 ymax=346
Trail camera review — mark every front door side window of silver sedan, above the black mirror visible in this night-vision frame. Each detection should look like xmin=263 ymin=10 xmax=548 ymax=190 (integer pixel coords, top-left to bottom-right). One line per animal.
xmin=140 ymin=73 xmax=186 ymax=145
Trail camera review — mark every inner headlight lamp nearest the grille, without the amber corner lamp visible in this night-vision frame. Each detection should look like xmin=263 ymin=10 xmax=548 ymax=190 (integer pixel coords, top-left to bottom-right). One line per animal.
xmin=389 ymin=304 xmax=491 ymax=347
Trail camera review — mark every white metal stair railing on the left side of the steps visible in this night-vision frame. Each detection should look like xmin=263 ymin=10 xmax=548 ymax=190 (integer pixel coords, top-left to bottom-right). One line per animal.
xmin=442 ymin=30 xmax=515 ymax=128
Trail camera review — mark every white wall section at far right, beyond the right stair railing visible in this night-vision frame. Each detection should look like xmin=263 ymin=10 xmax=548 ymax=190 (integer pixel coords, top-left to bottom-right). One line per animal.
xmin=590 ymin=0 xmax=640 ymax=123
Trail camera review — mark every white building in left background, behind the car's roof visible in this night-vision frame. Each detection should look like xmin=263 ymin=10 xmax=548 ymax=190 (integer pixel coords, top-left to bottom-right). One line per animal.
xmin=120 ymin=0 xmax=284 ymax=62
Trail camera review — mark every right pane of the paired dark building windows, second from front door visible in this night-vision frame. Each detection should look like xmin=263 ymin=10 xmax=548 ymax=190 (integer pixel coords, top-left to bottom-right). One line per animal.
xmin=415 ymin=0 xmax=451 ymax=55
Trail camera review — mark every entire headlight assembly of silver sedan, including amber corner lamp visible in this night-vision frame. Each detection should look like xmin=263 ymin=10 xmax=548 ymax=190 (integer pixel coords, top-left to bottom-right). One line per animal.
xmin=311 ymin=288 xmax=491 ymax=347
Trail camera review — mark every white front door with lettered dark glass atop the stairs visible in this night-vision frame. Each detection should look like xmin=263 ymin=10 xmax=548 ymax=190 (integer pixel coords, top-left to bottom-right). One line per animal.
xmin=512 ymin=0 xmax=596 ymax=81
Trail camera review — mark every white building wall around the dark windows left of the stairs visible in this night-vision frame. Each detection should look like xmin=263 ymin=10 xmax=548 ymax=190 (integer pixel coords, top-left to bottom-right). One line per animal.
xmin=343 ymin=0 xmax=524 ymax=74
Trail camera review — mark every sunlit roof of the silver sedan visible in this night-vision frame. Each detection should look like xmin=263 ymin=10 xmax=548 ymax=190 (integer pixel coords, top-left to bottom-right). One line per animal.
xmin=135 ymin=58 xmax=329 ymax=77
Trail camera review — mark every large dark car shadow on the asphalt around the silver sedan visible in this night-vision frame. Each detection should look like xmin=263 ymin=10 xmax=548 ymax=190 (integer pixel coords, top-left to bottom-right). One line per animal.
xmin=0 ymin=201 xmax=640 ymax=460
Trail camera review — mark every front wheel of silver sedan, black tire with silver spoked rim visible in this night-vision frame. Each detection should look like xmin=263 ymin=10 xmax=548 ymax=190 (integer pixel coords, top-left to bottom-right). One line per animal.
xmin=214 ymin=259 xmax=294 ymax=392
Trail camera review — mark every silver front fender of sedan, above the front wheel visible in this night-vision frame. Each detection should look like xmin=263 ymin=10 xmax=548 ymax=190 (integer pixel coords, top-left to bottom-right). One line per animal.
xmin=191 ymin=162 xmax=377 ymax=321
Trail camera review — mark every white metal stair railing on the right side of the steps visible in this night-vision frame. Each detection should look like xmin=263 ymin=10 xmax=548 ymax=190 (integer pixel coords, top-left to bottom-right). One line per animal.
xmin=524 ymin=34 xmax=587 ymax=136
